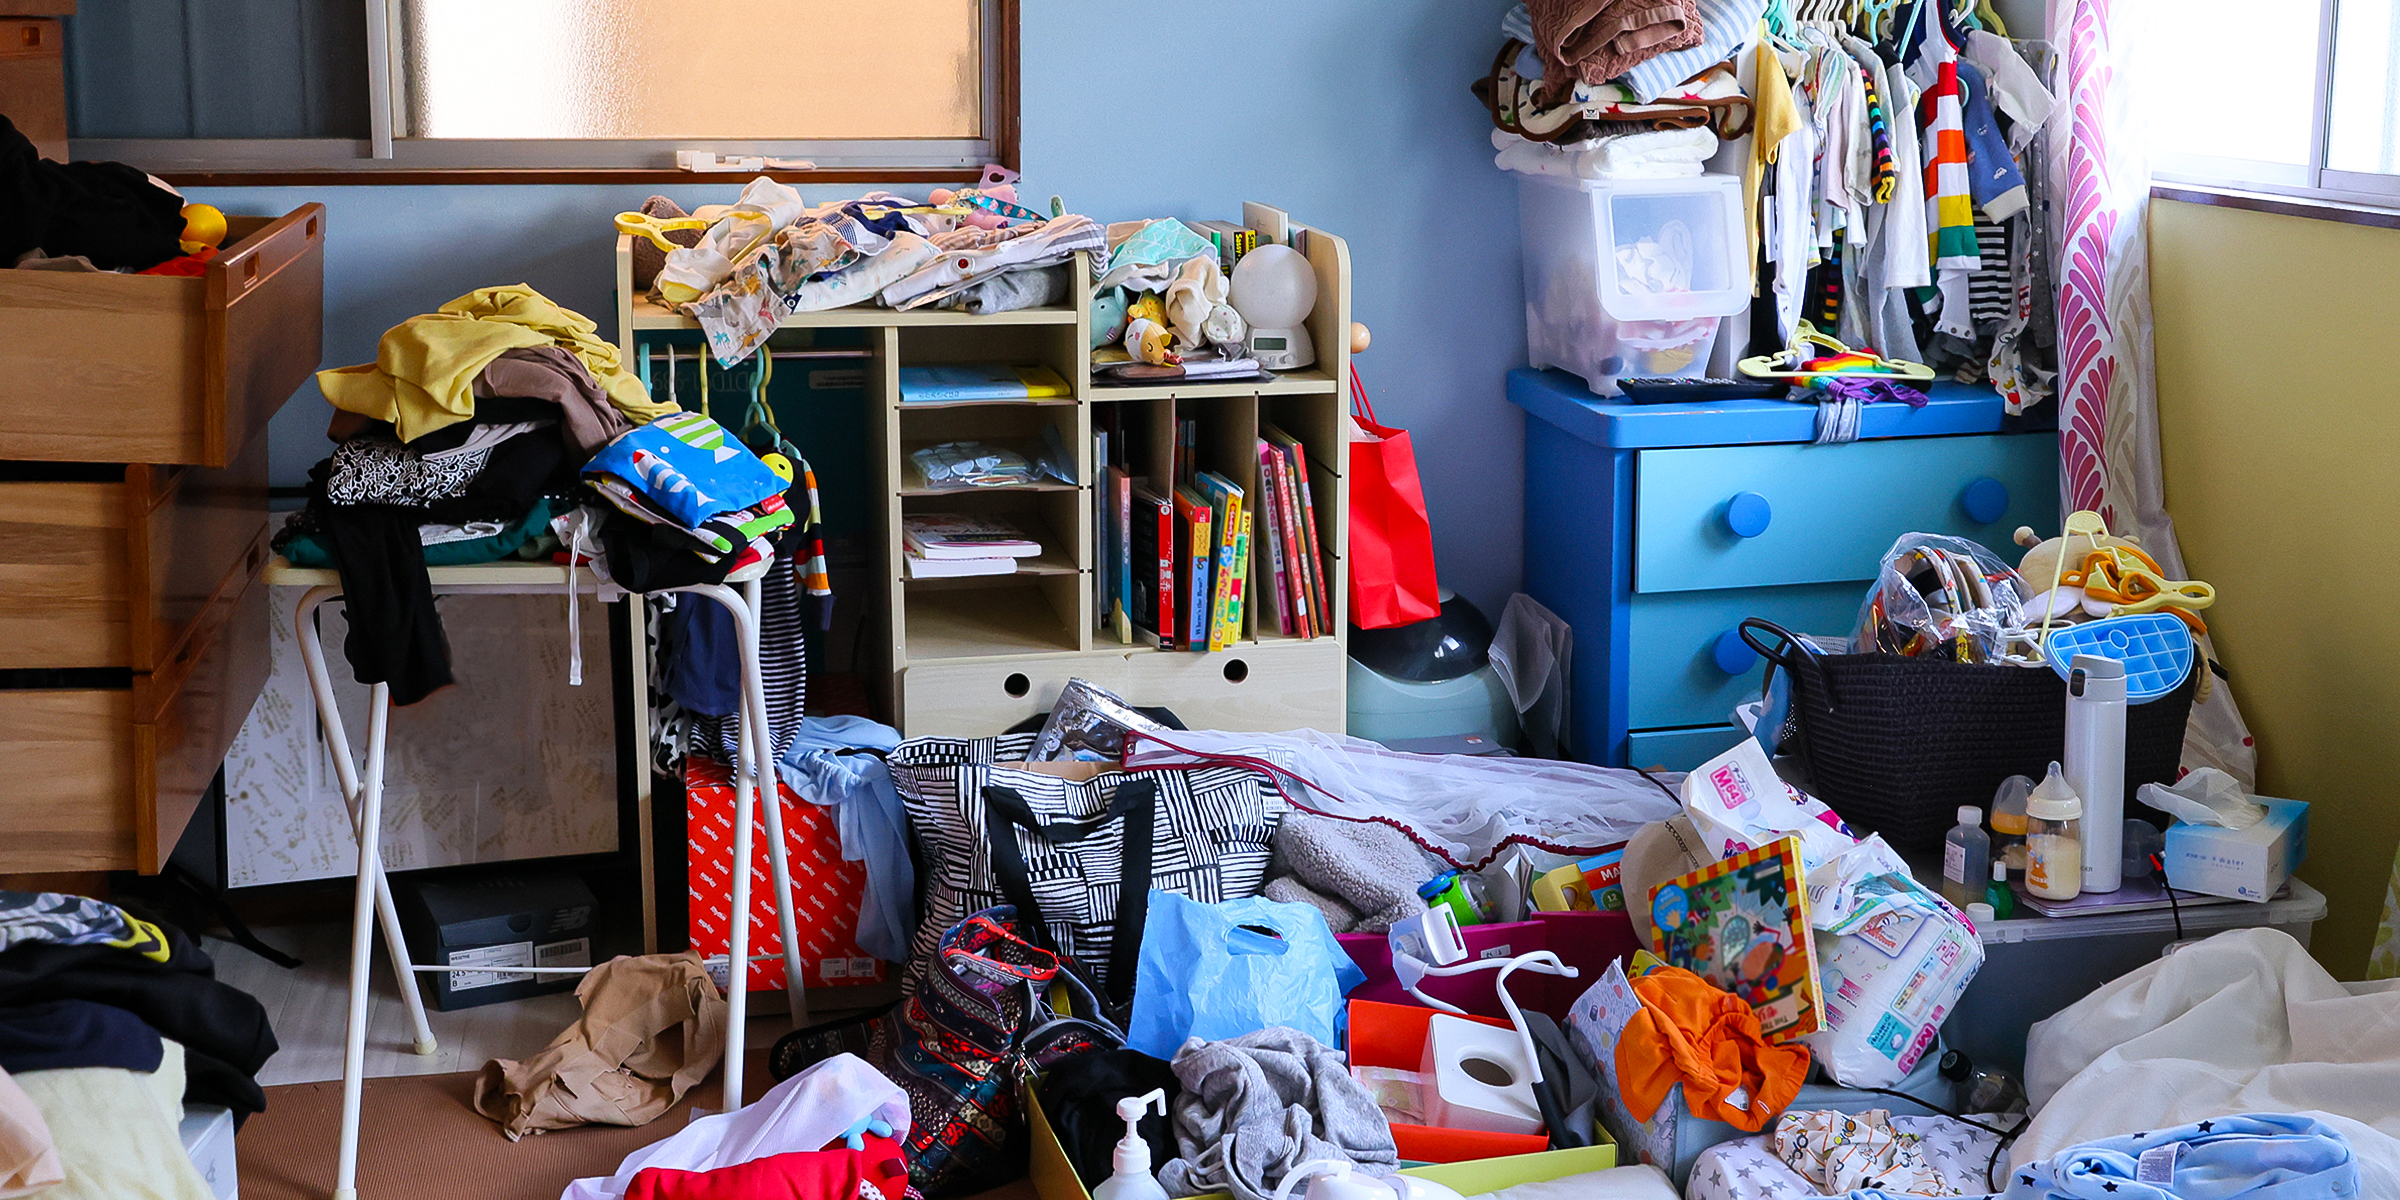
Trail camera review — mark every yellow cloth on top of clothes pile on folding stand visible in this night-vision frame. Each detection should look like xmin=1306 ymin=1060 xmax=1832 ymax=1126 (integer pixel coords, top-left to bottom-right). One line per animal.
xmin=317 ymin=283 xmax=674 ymax=442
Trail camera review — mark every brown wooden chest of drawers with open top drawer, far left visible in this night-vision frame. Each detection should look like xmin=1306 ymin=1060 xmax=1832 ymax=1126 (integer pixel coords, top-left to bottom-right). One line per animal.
xmin=0 ymin=204 xmax=324 ymax=871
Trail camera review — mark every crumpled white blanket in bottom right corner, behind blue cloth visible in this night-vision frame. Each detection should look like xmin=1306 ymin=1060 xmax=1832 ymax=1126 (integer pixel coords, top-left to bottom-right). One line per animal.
xmin=2009 ymin=929 xmax=2400 ymax=1195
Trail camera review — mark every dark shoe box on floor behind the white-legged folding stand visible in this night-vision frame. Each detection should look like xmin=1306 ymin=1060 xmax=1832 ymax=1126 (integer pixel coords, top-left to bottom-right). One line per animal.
xmin=398 ymin=874 xmax=598 ymax=1013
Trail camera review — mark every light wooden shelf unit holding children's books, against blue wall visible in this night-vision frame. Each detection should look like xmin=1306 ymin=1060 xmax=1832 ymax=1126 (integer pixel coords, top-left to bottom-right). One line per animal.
xmin=617 ymin=209 xmax=1351 ymax=737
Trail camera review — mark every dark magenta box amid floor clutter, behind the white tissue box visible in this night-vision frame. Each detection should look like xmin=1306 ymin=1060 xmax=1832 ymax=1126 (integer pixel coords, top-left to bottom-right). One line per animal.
xmin=1339 ymin=912 xmax=1642 ymax=1017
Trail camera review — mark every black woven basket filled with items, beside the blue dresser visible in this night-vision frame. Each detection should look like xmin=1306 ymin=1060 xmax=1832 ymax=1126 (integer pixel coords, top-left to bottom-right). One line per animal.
xmin=1742 ymin=617 xmax=2206 ymax=852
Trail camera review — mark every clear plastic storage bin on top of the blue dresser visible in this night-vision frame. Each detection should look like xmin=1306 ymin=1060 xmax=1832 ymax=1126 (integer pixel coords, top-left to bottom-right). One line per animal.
xmin=1517 ymin=175 xmax=1750 ymax=396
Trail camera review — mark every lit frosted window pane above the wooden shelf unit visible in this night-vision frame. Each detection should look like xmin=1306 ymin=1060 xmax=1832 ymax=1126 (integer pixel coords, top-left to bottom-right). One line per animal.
xmin=401 ymin=0 xmax=984 ymax=142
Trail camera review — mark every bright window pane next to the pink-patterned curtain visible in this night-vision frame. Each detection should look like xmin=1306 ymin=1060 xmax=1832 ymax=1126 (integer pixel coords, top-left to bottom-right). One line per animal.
xmin=2150 ymin=0 xmax=2313 ymax=168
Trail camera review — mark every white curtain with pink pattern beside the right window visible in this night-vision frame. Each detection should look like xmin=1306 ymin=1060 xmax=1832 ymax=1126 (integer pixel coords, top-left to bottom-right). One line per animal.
xmin=2050 ymin=0 xmax=2258 ymax=785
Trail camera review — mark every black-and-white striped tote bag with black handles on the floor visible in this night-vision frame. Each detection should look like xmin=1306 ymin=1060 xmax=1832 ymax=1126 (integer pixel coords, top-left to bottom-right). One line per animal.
xmin=888 ymin=734 xmax=1284 ymax=1003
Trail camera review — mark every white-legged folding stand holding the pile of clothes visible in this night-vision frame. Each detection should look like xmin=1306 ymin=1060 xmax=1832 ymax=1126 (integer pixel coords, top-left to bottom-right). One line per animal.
xmin=264 ymin=557 xmax=806 ymax=1200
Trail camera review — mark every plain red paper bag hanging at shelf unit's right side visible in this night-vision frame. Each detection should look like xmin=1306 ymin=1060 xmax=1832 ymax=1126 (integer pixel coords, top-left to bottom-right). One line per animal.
xmin=1349 ymin=367 xmax=1442 ymax=629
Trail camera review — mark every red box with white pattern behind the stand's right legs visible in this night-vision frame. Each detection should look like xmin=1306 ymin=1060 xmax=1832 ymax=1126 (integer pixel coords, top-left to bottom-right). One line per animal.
xmin=684 ymin=754 xmax=886 ymax=991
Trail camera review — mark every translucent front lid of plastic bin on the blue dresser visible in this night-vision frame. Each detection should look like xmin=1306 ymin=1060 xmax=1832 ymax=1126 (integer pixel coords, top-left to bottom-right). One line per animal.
xmin=1584 ymin=175 xmax=1750 ymax=322
